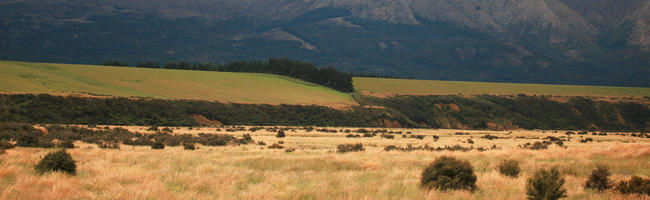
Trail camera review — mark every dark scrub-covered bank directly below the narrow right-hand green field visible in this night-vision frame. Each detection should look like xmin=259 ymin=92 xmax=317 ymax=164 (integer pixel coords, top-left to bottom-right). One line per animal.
xmin=355 ymin=95 xmax=650 ymax=134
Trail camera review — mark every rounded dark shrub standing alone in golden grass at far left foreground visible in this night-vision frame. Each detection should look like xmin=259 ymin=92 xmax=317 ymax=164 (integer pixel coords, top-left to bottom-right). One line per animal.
xmin=34 ymin=150 xmax=77 ymax=175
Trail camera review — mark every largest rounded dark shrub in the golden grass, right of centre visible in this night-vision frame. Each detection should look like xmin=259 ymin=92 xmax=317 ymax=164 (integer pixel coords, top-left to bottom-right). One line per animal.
xmin=420 ymin=156 xmax=476 ymax=191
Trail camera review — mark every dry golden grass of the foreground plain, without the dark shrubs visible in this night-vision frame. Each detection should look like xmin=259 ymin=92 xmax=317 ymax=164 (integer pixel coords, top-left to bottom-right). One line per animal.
xmin=0 ymin=127 xmax=650 ymax=199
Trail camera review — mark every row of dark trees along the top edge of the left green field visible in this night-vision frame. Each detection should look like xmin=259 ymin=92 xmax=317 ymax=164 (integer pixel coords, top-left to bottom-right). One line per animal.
xmin=103 ymin=58 xmax=354 ymax=92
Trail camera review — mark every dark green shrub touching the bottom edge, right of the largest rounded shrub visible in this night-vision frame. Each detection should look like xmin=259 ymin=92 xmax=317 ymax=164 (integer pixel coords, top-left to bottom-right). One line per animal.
xmin=526 ymin=168 xmax=567 ymax=200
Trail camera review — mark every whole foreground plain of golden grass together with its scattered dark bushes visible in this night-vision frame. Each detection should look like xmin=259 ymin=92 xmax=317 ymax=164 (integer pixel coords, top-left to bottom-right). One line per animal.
xmin=0 ymin=123 xmax=650 ymax=199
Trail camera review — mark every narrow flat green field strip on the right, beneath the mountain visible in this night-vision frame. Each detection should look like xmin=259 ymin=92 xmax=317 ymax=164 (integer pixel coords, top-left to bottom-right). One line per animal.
xmin=353 ymin=77 xmax=650 ymax=97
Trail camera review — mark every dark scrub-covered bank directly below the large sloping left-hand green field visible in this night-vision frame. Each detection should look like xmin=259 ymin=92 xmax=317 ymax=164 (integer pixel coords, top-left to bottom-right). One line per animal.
xmin=0 ymin=94 xmax=415 ymax=128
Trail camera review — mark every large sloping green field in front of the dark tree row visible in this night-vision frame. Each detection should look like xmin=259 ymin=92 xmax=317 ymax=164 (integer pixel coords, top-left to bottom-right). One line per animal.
xmin=0 ymin=61 xmax=355 ymax=106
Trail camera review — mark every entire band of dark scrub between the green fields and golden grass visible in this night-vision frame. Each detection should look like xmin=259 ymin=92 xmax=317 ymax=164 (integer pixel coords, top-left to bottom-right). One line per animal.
xmin=0 ymin=94 xmax=650 ymax=132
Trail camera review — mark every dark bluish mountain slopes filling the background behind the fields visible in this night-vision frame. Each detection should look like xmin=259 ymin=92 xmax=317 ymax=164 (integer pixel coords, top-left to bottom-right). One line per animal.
xmin=0 ymin=0 xmax=650 ymax=87
